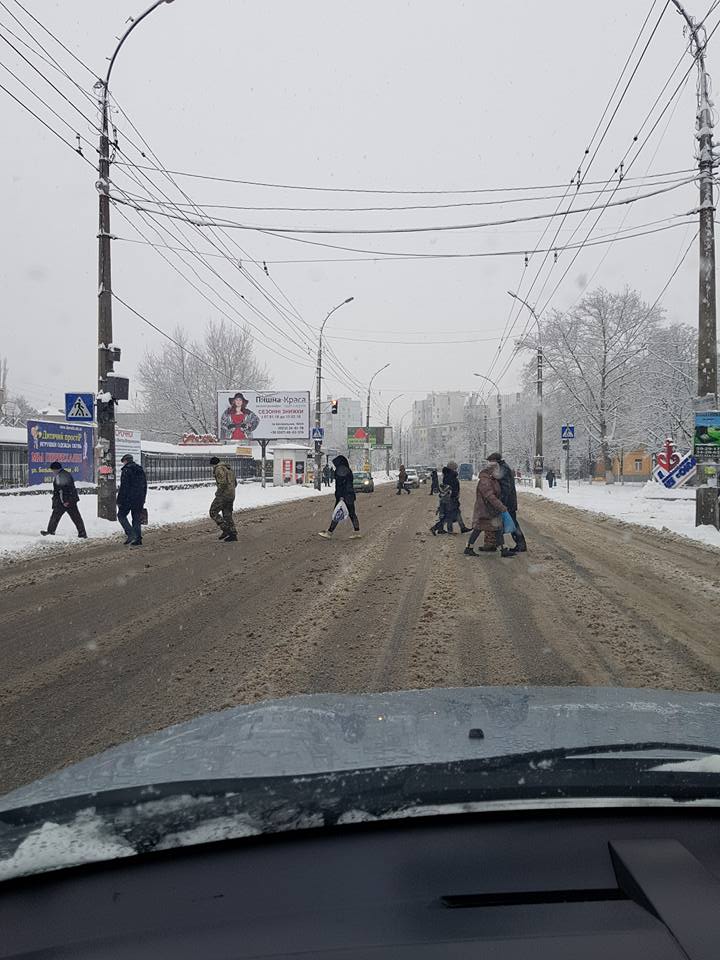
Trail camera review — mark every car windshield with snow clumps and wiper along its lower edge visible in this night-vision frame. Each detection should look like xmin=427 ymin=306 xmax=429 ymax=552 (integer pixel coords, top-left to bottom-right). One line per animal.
xmin=0 ymin=0 xmax=720 ymax=874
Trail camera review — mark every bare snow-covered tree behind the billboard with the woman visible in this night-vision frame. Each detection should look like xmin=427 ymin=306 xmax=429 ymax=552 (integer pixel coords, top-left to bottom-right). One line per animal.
xmin=138 ymin=320 xmax=270 ymax=442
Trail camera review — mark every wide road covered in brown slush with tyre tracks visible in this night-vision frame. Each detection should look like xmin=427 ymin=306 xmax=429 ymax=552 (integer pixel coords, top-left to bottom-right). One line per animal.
xmin=0 ymin=483 xmax=720 ymax=792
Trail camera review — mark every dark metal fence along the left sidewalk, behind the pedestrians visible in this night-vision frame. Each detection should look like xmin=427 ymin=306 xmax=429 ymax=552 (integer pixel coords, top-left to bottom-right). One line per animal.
xmin=0 ymin=443 xmax=272 ymax=487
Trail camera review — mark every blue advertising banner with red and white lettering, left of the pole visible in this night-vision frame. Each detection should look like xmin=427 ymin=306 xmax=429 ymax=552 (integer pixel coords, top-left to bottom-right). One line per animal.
xmin=28 ymin=420 xmax=95 ymax=486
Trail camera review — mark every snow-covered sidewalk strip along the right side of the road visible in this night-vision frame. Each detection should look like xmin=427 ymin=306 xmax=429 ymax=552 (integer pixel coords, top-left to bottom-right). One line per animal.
xmin=520 ymin=481 xmax=720 ymax=547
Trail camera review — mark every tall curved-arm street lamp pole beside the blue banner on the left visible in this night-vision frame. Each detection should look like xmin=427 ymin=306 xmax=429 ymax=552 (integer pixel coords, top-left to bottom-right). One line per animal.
xmin=95 ymin=0 xmax=172 ymax=520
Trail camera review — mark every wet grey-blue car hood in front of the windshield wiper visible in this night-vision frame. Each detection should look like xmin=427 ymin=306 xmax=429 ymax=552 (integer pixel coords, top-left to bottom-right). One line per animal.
xmin=0 ymin=687 xmax=720 ymax=811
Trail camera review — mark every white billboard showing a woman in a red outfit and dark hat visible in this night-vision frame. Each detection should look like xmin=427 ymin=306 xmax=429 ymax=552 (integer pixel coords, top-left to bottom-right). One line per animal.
xmin=217 ymin=390 xmax=310 ymax=443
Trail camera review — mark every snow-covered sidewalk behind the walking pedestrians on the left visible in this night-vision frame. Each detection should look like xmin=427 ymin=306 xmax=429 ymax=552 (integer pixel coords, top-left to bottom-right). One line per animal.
xmin=0 ymin=483 xmax=334 ymax=560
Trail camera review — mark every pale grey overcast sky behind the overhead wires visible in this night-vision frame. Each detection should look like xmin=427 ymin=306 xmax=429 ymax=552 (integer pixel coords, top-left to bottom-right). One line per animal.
xmin=0 ymin=0 xmax=720 ymax=422
